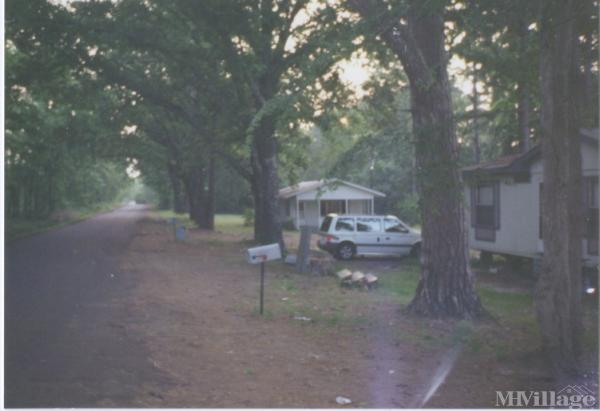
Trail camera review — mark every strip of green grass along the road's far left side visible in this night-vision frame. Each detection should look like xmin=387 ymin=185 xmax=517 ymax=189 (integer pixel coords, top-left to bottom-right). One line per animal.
xmin=4 ymin=203 xmax=126 ymax=243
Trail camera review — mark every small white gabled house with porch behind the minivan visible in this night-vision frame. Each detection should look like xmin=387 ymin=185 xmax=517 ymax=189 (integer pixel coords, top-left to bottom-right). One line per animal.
xmin=279 ymin=179 xmax=385 ymax=228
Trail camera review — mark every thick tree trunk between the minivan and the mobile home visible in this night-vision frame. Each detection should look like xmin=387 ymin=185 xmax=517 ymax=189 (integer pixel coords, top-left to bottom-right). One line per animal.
xmin=351 ymin=0 xmax=483 ymax=318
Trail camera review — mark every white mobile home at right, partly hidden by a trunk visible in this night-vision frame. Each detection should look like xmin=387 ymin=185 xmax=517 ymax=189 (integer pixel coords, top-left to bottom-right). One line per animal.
xmin=463 ymin=129 xmax=598 ymax=266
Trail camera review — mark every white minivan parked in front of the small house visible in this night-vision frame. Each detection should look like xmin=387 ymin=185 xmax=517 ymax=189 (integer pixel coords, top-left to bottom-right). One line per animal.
xmin=318 ymin=214 xmax=421 ymax=260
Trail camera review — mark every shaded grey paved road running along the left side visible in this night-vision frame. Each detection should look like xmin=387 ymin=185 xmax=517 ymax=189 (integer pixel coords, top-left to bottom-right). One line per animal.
xmin=5 ymin=206 xmax=167 ymax=407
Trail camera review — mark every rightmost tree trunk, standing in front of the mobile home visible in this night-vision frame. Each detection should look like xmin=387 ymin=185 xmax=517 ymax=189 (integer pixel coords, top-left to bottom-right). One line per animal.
xmin=535 ymin=0 xmax=583 ymax=376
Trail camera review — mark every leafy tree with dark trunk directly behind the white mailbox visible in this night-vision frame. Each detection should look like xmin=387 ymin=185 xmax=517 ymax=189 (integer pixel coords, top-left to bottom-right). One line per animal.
xmin=188 ymin=0 xmax=354 ymax=246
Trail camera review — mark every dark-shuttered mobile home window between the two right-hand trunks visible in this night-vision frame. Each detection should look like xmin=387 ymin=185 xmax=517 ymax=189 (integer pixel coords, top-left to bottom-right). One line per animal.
xmin=471 ymin=182 xmax=500 ymax=241
